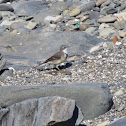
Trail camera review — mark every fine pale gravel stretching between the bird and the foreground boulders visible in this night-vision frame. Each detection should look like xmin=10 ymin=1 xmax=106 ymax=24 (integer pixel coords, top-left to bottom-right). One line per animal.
xmin=0 ymin=42 xmax=126 ymax=126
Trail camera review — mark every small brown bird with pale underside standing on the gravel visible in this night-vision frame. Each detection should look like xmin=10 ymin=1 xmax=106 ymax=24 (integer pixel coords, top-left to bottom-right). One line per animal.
xmin=35 ymin=45 xmax=68 ymax=70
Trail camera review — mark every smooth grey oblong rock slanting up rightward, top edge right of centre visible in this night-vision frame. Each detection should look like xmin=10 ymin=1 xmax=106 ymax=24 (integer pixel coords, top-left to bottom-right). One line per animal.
xmin=77 ymin=1 xmax=95 ymax=12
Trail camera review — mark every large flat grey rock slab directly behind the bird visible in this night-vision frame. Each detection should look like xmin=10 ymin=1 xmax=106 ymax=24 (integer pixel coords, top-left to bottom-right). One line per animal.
xmin=0 ymin=31 xmax=104 ymax=61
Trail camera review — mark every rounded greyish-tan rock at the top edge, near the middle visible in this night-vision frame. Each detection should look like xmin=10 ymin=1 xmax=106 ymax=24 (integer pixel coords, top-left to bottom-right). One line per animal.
xmin=52 ymin=1 xmax=69 ymax=11
